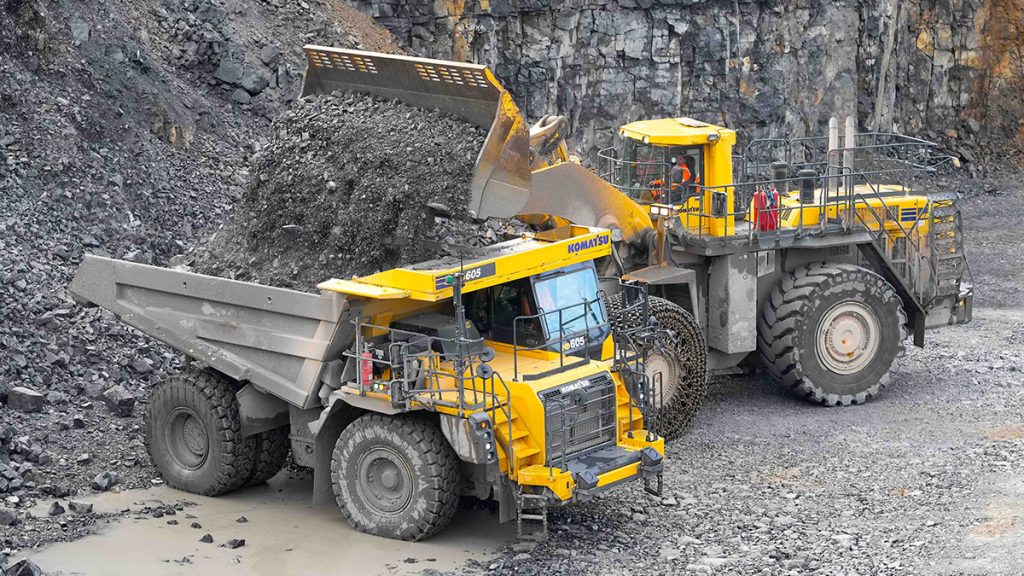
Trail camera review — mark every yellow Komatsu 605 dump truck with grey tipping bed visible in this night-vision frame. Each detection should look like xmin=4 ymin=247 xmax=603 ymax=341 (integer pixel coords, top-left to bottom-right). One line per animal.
xmin=71 ymin=227 xmax=665 ymax=540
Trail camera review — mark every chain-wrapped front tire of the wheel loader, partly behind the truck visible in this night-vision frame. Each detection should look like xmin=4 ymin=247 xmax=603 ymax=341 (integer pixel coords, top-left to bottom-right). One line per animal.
xmin=605 ymin=294 xmax=708 ymax=440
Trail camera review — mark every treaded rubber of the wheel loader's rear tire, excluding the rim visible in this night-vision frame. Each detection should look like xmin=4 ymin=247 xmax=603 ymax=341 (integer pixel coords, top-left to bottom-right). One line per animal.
xmin=758 ymin=262 xmax=907 ymax=406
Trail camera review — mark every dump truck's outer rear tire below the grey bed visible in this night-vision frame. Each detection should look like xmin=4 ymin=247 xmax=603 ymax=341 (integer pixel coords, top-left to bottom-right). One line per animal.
xmin=145 ymin=371 xmax=256 ymax=496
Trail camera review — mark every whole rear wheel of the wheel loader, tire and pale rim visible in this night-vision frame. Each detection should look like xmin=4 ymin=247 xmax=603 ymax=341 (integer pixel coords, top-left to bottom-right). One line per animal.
xmin=758 ymin=263 xmax=907 ymax=406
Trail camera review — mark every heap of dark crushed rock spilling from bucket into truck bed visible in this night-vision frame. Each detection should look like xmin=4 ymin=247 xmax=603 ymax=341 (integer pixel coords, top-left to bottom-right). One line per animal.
xmin=194 ymin=93 xmax=521 ymax=290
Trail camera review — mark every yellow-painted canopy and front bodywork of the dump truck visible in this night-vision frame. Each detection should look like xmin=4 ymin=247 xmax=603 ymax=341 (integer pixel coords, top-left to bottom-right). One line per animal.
xmin=318 ymin=225 xmax=665 ymax=501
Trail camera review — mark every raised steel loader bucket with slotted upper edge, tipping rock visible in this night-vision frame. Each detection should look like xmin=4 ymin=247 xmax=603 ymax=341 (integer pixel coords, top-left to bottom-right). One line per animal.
xmin=301 ymin=46 xmax=530 ymax=218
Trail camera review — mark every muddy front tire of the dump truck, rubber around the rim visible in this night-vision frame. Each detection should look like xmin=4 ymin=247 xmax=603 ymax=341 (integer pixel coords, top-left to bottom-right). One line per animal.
xmin=331 ymin=414 xmax=461 ymax=540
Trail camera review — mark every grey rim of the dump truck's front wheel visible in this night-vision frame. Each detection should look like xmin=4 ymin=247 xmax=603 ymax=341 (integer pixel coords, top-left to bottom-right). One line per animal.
xmin=356 ymin=447 xmax=413 ymax=516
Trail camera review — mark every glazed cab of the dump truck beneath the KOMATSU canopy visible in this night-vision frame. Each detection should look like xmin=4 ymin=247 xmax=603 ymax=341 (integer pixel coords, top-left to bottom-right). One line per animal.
xmin=465 ymin=261 xmax=611 ymax=357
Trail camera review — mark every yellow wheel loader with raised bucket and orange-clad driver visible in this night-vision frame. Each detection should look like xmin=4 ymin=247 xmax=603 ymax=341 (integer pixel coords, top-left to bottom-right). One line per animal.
xmin=288 ymin=46 xmax=973 ymax=432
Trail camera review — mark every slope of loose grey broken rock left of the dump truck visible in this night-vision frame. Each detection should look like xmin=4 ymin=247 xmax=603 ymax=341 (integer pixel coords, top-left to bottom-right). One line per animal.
xmin=0 ymin=0 xmax=397 ymax=553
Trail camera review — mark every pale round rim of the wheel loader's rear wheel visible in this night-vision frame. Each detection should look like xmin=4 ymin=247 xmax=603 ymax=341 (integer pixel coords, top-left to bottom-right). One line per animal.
xmin=815 ymin=301 xmax=881 ymax=374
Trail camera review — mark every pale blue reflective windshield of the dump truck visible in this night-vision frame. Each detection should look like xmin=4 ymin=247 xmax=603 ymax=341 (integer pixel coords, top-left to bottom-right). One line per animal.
xmin=534 ymin=266 xmax=604 ymax=342
